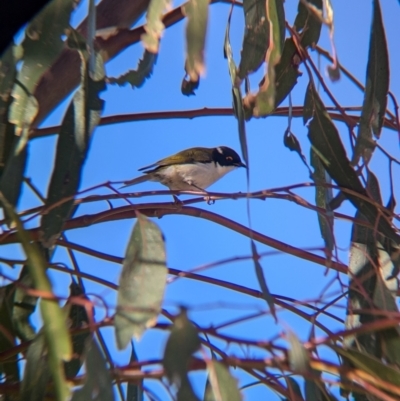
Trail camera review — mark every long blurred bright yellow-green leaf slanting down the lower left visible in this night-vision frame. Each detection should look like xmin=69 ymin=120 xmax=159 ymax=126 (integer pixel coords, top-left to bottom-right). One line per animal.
xmin=0 ymin=193 xmax=72 ymax=400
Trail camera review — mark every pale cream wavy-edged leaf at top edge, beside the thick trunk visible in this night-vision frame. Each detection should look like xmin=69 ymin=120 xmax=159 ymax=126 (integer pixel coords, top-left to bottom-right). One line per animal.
xmin=141 ymin=0 xmax=171 ymax=54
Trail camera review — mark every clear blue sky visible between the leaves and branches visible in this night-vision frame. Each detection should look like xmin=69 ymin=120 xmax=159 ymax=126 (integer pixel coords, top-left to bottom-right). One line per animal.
xmin=6 ymin=0 xmax=400 ymax=400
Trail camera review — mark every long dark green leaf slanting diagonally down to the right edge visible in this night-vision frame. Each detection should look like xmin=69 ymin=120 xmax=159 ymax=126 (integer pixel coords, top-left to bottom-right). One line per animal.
xmin=304 ymin=82 xmax=400 ymax=244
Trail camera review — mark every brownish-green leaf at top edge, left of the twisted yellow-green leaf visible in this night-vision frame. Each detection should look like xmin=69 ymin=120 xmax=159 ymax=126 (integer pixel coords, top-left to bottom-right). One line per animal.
xmin=237 ymin=0 xmax=269 ymax=80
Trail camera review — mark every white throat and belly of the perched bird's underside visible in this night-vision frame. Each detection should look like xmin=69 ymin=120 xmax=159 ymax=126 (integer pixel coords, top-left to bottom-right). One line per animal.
xmin=154 ymin=163 xmax=237 ymax=191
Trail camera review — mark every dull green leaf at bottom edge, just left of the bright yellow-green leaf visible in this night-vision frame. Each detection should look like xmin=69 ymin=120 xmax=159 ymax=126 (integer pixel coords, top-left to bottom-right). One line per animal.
xmin=20 ymin=332 xmax=50 ymax=401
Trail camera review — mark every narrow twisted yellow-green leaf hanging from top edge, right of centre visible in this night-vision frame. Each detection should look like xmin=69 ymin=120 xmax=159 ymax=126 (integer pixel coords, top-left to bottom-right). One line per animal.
xmin=253 ymin=0 xmax=285 ymax=116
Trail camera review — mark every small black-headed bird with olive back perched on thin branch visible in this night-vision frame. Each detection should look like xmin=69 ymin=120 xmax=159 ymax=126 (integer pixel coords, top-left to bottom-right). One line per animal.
xmin=122 ymin=146 xmax=247 ymax=192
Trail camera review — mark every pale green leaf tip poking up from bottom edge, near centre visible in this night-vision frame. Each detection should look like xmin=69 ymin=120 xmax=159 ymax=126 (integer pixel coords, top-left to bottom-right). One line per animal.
xmin=204 ymin=360 xmax=242 ymax=401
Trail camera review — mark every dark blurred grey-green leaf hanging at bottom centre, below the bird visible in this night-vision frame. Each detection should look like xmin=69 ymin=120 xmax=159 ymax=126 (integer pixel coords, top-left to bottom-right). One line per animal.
xmin=163 ymin=307 xmax=201 ymax=386
